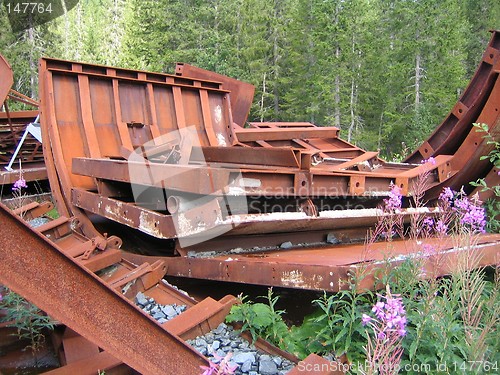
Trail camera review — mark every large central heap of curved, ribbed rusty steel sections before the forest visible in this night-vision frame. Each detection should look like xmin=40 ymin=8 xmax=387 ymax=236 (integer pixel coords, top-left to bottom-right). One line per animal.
xmin=40 ymin=32 xmax=500 ymax=291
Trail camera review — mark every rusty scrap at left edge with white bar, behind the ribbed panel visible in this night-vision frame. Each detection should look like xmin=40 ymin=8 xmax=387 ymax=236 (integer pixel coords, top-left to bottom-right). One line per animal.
xmin=0 ymin=54 xmax=47 ymax=185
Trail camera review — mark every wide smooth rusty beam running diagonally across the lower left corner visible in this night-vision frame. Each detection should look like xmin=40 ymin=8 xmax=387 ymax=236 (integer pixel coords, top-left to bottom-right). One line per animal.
xmin=0 ymin=205 xmax=207 ymax=375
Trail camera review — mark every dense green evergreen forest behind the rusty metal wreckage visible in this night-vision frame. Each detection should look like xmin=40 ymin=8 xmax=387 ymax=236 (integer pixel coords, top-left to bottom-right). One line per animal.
xmin=0 ymin=0 xmax=500 ymax=157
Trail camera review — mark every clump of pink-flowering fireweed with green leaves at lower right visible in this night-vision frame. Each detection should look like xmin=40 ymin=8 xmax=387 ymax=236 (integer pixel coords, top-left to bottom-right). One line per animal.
xmin=228 ymin=181 xmax=500 ymax=374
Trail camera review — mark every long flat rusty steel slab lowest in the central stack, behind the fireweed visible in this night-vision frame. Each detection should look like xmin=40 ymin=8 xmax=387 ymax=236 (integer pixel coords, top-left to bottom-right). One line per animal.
xmin=123 ymin=234 xmax=500 ymax=292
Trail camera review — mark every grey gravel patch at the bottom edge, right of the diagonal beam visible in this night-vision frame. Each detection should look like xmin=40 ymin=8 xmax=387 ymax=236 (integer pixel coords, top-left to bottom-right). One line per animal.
xmin=187 ymin=323 xmax=294 ymax=375
